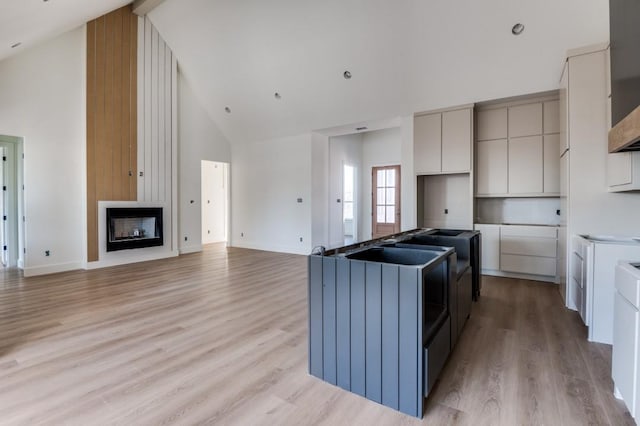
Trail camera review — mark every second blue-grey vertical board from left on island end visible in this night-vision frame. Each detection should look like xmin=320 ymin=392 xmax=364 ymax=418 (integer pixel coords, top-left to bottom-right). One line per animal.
xmin=322 ymin=257 xmax=336 ymax=385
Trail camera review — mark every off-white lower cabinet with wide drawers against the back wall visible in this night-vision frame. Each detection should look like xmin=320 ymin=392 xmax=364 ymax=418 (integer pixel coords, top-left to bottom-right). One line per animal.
xmin=475 ymin=224 xmax=558 ymax=281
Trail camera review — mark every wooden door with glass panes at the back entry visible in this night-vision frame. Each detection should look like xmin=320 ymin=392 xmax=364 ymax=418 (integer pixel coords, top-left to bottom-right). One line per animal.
xmin=371 ymin=166 xmax=400 ymax=238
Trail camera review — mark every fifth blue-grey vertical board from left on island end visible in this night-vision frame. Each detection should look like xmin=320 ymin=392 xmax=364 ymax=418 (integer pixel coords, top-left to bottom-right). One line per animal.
xmin=365 ymin=263 xmax=382 ymax=403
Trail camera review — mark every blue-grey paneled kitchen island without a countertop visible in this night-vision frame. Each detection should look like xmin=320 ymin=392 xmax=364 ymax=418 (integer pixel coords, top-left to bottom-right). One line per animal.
xmin=309 ymin=229 xmax=472 ymax=417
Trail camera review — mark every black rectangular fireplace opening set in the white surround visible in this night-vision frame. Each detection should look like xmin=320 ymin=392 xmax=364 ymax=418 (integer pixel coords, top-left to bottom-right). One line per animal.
xmin=107 ymin=207 xmax=164 ymax=251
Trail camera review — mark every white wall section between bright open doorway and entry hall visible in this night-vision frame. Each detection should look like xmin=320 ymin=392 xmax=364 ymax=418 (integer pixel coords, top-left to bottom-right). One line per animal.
xmin=231 ymin=133 xmax=312 ymax=254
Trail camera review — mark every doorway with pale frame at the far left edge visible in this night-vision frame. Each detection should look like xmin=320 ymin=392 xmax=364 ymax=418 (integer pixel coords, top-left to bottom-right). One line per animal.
xmin=0 ymin=135 xmax=24 ymax=268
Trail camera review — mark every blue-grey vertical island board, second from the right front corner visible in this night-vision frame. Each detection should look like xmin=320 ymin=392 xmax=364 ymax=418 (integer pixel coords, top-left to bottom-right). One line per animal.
xmin=382 ymin=265 xmax=399 ymax=410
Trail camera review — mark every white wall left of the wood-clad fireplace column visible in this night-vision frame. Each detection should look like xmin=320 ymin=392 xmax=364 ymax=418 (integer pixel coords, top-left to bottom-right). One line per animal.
xmin=0 ymin=26 xmax=86 ymax=275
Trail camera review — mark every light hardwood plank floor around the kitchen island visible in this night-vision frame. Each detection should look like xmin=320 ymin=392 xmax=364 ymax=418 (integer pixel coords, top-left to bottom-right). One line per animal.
xmin=0 ymin=244 xmax=633 ymax=425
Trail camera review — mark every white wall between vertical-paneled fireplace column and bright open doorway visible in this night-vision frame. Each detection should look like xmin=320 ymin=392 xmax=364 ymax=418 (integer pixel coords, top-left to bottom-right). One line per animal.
xmin=178 ymin=72 xmax=231 ymax=253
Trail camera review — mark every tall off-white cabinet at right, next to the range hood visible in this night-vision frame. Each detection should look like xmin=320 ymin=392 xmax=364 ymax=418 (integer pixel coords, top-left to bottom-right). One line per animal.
xmin=558 ymin=44 xmax=616 ymax=309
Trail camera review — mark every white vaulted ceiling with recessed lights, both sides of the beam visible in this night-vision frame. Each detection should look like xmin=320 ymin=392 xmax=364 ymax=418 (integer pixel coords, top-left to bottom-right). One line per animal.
xmin=0 ymin=0 xmax=609 ymax=143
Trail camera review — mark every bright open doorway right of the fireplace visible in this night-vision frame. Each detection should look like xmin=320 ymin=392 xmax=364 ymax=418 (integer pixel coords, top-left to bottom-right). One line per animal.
xmin=201 ymin=160 xmax=229 ymax=244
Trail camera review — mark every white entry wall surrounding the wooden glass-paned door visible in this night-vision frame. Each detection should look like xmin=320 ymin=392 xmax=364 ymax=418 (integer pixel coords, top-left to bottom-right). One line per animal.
xmin=358 ymin=127 xmax=400 ymax=241
